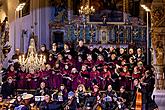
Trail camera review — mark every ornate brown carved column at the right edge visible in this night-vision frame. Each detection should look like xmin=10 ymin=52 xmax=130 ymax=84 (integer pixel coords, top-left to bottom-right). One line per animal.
xmin=151 ymin=0 xmax=165 ymax=90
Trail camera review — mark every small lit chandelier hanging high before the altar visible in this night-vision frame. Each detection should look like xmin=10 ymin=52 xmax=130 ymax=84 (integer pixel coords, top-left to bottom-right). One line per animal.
xmin=79 ymin=5 xmax=95 ymax=16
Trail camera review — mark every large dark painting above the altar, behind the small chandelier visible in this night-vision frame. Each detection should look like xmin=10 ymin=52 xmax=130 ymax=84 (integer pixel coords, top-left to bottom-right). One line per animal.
xmin=89 ymin=0 xmax=124 ymax=22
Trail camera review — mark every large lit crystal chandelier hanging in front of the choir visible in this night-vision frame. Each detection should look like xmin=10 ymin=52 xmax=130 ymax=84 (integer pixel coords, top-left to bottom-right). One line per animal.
xmin=19 ymin=38 xmax=46 ymax=70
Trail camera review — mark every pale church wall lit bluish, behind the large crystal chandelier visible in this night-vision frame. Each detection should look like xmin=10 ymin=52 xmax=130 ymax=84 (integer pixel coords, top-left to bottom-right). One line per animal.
xmin=8 ymin=0 xmax=51 ymax=57
